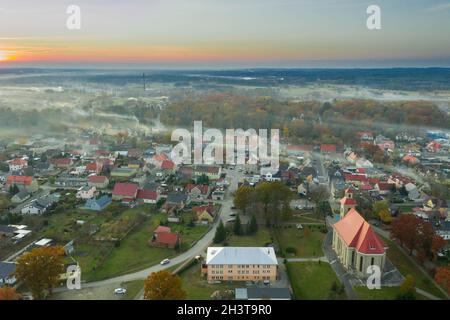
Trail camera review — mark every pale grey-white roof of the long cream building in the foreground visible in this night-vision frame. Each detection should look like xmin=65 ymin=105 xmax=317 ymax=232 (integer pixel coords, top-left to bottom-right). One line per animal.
xmin=206 ymin=247 xmax=278 ymax=265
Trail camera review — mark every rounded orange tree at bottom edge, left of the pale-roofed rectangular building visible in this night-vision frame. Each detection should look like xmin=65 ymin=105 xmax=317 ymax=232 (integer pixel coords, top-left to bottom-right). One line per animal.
xmin=144 ymin=270 xmax=186 ymax=300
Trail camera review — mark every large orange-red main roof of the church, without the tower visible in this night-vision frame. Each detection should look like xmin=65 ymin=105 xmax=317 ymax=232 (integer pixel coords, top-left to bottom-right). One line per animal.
xmin=333 ymin=209 xmax=385 ymax=254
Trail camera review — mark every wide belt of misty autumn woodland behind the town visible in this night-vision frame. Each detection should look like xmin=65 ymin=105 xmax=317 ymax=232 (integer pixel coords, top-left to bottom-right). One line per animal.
xmin=161 ymin=93 xmax=450 ymax=143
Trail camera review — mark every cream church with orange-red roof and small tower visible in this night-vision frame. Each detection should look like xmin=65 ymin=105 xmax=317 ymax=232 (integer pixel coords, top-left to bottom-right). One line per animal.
xmin=332 ymin=189 xmax=387 ymax=278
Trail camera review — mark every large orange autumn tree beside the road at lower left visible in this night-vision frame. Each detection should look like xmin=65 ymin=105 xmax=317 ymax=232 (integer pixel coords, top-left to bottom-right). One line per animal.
xmin=15 ymin=246 xmax=64 ymax=299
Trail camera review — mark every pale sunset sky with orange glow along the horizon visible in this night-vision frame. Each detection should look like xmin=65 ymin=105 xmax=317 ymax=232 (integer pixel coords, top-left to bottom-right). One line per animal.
xmin=0 ymin=0 xmax=450 ymax=68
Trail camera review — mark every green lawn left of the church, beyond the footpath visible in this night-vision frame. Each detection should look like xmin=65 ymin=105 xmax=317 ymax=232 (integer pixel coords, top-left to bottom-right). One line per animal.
xmin=276 ymin=226 xmax=325 ymax=258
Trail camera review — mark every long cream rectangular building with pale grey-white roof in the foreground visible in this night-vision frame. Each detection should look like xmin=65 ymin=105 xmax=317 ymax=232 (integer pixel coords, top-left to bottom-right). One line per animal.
xmin=202 ymin=247 xmax=278 ymax=281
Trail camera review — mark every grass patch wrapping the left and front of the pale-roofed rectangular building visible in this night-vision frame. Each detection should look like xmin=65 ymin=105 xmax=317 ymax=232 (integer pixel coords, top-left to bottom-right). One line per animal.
xmin=179 ymin=263 xmax=245 ymax=300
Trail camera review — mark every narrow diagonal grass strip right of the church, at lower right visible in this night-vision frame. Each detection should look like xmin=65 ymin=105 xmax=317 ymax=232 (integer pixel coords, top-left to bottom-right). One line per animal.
xmin=382 ymin=237 xmax=445 ymax=298
